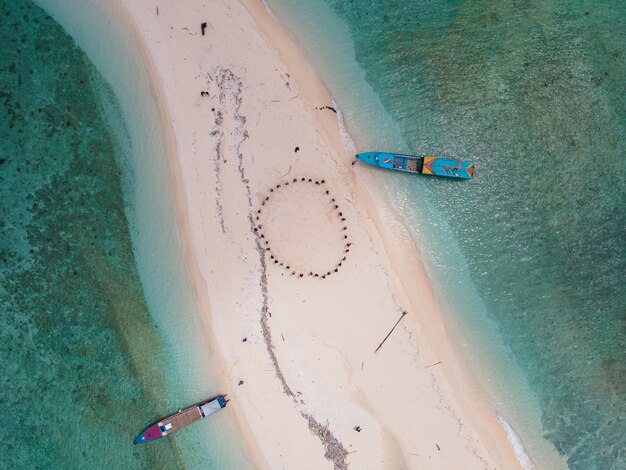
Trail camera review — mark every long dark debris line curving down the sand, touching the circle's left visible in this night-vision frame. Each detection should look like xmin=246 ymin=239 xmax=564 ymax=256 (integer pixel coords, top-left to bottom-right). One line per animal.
xmin=215 ymin=68 xmax=348 ymax=470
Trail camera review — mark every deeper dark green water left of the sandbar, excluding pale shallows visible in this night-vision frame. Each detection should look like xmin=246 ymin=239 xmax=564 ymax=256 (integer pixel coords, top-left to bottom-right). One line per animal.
xmin=0 ymin=0 xmax=184 ymax=468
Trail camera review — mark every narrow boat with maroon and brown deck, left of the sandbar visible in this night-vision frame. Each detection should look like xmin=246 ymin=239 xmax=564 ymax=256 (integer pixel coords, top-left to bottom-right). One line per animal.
xmin=135 ymin=395 xmax=228 ymax=444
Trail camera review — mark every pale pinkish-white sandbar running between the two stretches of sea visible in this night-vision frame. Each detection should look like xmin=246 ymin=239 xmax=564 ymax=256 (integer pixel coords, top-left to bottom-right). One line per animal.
xmin=62 ymin=0 xmax=519 ymax=469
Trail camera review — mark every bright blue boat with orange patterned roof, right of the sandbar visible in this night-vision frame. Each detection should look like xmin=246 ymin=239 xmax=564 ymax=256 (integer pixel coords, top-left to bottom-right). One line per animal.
xmin=355 ymin=152 xmax=474 ymax=179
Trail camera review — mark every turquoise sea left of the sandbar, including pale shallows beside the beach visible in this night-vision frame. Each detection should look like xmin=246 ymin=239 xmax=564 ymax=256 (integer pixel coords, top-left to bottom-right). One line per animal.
xmin=0 ymin=0 xmax=248 ymax=469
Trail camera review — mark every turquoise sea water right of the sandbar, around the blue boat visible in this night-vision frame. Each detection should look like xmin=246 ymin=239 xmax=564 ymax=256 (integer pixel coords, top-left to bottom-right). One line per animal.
xmin=269 ymin=0 xmax=626 ymax=470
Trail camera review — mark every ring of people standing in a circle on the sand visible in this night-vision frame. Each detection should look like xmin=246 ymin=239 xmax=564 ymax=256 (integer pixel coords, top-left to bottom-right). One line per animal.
xmin=254 ymin=178 xmax=352 ymax=279
